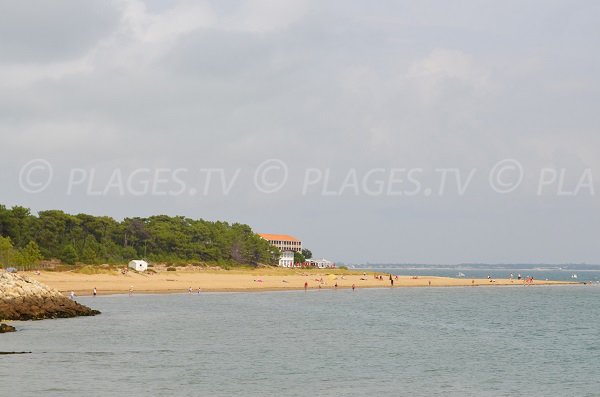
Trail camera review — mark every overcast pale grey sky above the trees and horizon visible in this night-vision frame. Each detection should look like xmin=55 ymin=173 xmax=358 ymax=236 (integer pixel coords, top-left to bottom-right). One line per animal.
xmin=0 ymin=0 xmax=600 ymax=264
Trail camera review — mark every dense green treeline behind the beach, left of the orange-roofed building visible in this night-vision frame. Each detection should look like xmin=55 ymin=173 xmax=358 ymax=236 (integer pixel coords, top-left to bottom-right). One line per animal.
xmin=0 ymin=205 xmax=279 ymax=266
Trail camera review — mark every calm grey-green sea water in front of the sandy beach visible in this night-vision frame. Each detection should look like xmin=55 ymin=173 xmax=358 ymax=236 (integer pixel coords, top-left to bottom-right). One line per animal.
xmin=0 ymin=286 xmax=600 ymax=396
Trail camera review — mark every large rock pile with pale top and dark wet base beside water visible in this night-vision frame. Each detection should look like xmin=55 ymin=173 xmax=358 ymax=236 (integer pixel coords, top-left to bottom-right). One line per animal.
xmin=0 ymin=273 xmax=100 ymax=320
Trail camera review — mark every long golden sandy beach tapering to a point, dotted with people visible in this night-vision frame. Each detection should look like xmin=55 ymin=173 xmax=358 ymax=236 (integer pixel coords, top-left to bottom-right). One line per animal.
xmin=25 ymin=268 xmax=573 ymax=295
